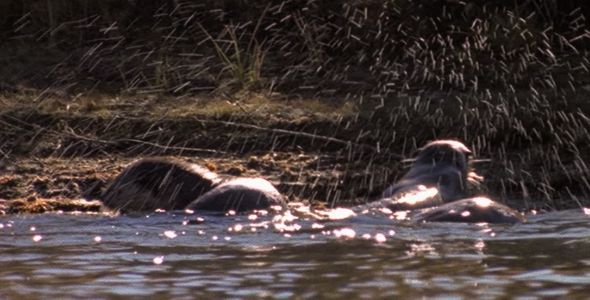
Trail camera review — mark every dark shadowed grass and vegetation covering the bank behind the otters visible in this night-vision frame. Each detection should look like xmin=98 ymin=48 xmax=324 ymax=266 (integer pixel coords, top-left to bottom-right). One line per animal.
xmin=0 ymin=0 xmax=590 ymax=209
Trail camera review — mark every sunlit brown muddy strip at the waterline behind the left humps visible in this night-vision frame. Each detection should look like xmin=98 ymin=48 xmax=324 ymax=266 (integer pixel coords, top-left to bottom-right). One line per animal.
xmin=0 ymin=152 xmax=398 ymax=213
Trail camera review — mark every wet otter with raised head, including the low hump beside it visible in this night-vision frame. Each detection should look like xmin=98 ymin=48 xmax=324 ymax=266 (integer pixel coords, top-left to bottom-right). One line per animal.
xmin=357 ymin=140 xmax=526 ymax=223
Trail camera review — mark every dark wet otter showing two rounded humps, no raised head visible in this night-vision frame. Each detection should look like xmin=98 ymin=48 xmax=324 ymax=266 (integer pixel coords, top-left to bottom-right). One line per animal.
xmin=99 ymin=158 xmax=286 ymax=213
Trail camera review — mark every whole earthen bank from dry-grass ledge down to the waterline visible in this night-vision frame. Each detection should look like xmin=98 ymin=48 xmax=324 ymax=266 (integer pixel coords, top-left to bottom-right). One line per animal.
xmin=0 ymin=103 xmax=590 ymax=213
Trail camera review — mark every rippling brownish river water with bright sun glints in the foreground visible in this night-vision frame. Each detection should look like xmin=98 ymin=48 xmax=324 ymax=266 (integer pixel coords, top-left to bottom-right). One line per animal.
xmin=0 ymin=210 xmax=590 ymax=299
